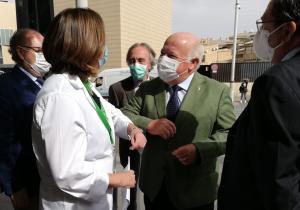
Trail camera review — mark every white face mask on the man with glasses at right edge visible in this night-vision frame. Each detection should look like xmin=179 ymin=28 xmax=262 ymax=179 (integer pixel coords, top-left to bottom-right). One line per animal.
xmin=253 ymin=23 xmax=286 ymax=61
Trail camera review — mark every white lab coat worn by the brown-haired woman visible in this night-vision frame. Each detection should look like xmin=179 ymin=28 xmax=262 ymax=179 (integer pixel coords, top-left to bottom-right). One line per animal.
xmin=32 ymin=74 xmax=131 ymax=210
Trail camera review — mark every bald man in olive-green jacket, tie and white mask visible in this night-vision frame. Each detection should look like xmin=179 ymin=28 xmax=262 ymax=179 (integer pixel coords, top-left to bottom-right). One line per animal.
xmin=123 ymin=33 xmax=235 ymax=210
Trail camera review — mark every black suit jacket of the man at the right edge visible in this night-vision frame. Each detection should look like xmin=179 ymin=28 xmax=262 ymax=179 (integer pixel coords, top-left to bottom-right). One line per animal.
xmin=218 ymin=54 xmax=300 ymax=210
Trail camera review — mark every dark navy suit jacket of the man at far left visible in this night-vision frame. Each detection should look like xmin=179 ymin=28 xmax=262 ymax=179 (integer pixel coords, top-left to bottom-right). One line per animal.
xmin=0 ymin=66 xmax=40 ymax=195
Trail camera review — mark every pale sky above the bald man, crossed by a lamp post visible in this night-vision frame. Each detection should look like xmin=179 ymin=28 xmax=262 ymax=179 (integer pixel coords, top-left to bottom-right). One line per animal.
xmin=172 ymin=0 xmax=269 ymax=38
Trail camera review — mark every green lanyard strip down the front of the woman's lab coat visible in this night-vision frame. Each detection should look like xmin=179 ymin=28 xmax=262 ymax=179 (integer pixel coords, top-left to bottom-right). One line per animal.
xmin=83 ymin=82 xmax=114 ymax=144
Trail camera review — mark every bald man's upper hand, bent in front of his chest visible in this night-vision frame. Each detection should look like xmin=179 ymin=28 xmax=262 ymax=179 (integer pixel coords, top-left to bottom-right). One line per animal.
xmin=146 ymin=118 xmax=176 ymax=139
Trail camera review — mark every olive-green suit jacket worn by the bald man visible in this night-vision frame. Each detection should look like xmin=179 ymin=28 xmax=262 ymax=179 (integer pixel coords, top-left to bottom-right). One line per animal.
xmin=122 ymin=73 xmax=235 ymax=208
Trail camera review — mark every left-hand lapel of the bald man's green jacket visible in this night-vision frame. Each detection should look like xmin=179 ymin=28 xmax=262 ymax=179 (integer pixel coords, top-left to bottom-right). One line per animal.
xmin=154 ymin=81 xmax=167 ymax=118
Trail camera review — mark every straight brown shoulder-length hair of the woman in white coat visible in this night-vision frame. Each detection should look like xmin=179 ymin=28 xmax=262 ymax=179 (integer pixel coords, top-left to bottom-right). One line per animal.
xmin=43 ymin=8 xmax=105 ymax=81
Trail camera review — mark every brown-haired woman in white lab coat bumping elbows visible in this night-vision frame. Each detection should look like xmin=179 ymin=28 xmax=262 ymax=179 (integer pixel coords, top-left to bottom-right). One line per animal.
xmin=32 ymin=8 xmax=146 ymax=210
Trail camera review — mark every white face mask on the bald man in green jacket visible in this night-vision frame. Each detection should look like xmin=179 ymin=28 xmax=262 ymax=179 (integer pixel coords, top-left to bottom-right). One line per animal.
xmin=157 ymin=55 xmax=186 ymax=83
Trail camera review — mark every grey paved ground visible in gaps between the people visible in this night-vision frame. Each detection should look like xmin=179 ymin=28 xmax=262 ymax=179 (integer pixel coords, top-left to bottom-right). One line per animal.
xmin=0 ymin=102 xmax=246 ymax=210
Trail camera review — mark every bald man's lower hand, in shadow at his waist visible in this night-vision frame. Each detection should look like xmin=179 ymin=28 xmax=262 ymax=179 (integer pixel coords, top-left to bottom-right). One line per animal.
xmin=172 ymin=144 xmax=197 ymax=165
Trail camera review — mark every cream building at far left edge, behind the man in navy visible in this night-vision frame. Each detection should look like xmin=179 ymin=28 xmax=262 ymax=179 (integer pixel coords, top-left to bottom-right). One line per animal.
xmin=0 ymin=1 xmax=17 ymax=64
